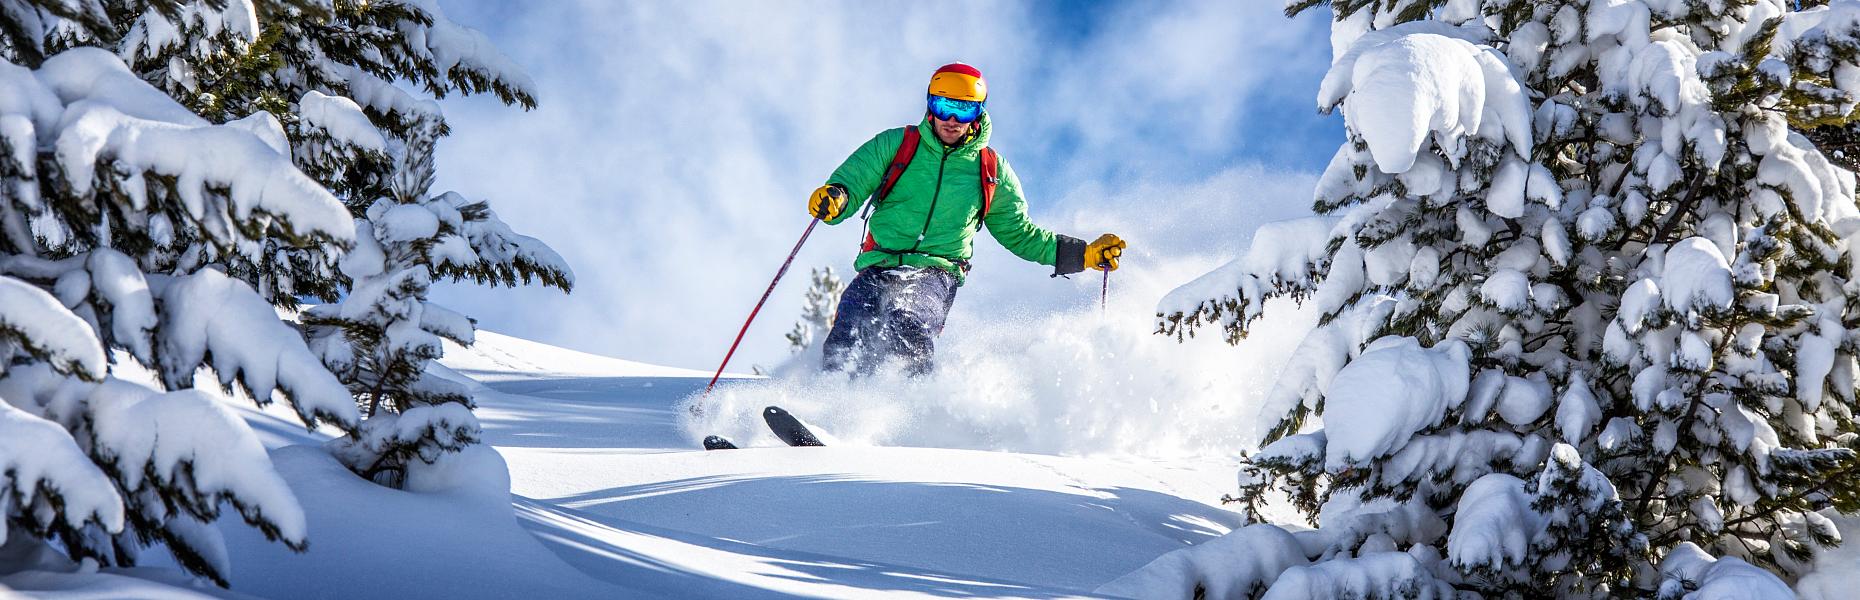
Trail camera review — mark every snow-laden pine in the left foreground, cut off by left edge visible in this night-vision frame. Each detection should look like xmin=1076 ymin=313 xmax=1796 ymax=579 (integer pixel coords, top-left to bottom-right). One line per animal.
xmin=0 ymin=28 xmax=357 ymax=585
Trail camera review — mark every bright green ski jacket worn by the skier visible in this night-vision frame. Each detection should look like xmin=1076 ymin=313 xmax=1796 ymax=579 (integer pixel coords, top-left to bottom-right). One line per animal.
xmin=828 ymin=113 xmax=1084 ymax=282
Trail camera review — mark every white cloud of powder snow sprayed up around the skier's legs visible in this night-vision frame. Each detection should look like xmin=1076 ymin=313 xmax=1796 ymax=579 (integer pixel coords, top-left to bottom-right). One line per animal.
xmin=691 ymin=293 xmax=1328 ymax=458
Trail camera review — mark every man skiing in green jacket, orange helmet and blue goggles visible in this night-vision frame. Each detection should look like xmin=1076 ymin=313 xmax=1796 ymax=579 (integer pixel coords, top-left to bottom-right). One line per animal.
xmin=807 ymin=63 xmax=1123 ymax=375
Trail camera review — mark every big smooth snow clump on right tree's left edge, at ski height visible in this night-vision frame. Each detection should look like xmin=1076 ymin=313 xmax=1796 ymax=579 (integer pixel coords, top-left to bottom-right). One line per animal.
xmin=1324 ymin=336 xmax=1471 ymax=472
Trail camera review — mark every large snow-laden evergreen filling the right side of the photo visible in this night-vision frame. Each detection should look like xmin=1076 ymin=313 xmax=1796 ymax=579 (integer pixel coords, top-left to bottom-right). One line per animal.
xmin=1133 ymin=0 xmax=1860 ymax=598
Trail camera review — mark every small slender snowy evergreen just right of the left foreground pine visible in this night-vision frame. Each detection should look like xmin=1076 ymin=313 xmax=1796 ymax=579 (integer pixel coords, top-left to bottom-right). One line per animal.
xmin=303 ymin=112 xmax=573 ymax=487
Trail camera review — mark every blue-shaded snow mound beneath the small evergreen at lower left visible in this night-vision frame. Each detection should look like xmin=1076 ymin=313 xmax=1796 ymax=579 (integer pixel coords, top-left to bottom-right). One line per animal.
xmin=221 ymin=446 xmax=610 ymax=598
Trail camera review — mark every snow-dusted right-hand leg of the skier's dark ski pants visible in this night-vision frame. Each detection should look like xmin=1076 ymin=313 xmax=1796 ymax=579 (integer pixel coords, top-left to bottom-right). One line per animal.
xmin=882 ymin=267 xmax=956 ymax=375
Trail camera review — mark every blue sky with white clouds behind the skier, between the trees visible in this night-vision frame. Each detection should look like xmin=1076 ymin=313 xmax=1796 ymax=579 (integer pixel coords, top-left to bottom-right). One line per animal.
xmin=437 ymin=0 xmax=1343 ymax=372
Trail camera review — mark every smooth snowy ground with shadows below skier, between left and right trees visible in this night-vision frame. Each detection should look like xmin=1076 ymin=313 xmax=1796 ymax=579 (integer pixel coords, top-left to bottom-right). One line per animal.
xmin=188 ymin=333 xmax=1241 ymax=598
